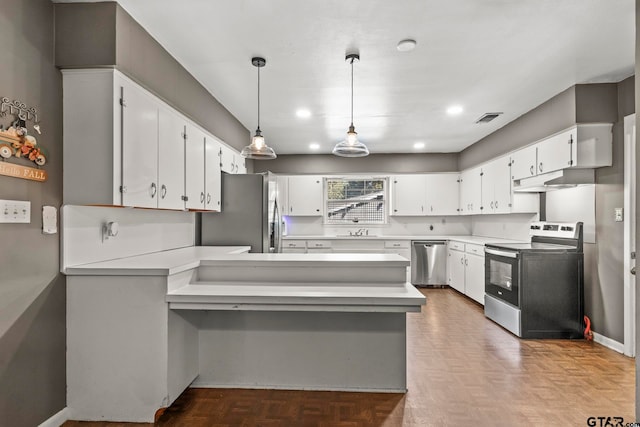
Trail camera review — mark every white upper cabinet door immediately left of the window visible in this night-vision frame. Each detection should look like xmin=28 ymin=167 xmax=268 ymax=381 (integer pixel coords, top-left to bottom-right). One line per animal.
xmin=286 ymin=175 xmax=324 ymax=216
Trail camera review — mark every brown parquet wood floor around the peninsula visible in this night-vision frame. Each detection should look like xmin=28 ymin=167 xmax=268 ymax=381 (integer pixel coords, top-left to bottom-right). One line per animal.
xmin=64 ymin=288 xmax=635 ymax=427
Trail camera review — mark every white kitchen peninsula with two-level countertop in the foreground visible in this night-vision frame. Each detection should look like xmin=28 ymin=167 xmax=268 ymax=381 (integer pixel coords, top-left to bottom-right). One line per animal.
xmin=64 ymin=247 xmax=425 ymax=422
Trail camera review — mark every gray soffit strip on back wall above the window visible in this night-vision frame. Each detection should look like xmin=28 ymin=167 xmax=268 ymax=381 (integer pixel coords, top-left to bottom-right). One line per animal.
xmin=254 ymin=153 xmax=458 ymax=174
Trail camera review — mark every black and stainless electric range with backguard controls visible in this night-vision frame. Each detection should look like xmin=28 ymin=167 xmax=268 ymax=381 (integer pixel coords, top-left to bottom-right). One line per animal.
xmin=484 ymin=222 xmax=584 ymax=338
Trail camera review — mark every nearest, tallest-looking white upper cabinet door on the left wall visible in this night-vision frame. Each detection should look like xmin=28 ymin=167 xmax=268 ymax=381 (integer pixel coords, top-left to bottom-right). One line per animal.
xmin=116 ymin=79 xmax=159 ymax=208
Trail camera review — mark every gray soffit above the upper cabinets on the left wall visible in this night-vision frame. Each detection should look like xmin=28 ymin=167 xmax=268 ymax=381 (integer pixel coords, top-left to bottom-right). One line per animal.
xmin=55 ymin=2 xmax=250 ymax=150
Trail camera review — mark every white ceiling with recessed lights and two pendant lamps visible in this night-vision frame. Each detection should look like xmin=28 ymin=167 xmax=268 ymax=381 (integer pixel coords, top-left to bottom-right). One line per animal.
xmin=69 ymin=0 xmax=635 ymax=154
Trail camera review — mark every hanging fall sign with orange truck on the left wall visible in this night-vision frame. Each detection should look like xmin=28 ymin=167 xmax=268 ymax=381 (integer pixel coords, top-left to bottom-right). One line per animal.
xmin=0 ymin=97 xmax=47 ymax=182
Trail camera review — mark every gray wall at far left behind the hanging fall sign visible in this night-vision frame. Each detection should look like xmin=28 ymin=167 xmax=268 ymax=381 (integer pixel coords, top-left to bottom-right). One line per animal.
xmin=0 ymin=0 xmax=66 ymax=427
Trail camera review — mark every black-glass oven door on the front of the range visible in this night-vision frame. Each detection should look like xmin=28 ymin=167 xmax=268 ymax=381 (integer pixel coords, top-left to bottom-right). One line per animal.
xmin=484 ymin=247 xmax=520 ymax=307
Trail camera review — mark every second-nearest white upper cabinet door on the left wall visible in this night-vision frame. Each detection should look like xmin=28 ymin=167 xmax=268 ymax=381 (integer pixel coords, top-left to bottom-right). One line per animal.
xmin=158 ymin=107 xmax=186 ymax=209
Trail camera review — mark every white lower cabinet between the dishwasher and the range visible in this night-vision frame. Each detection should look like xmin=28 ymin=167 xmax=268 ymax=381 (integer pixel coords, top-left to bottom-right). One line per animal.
xmin=448 ymin=241 xmax=485 ymax=305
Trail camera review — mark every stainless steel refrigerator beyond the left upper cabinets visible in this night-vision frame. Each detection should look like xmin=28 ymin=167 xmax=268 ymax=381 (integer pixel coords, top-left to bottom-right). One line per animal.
xmin=200 ymin=172 xmax=282 ymax=253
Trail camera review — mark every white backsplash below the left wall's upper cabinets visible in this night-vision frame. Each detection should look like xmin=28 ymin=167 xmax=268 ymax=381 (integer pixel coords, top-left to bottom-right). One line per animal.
xmin=60 ymin=205 xmax=195 ymax=270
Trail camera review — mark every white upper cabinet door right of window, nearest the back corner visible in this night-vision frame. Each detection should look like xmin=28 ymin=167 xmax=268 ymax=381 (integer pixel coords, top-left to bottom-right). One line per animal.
xmin=425 ymin=173 xmax=460 ymax=215
